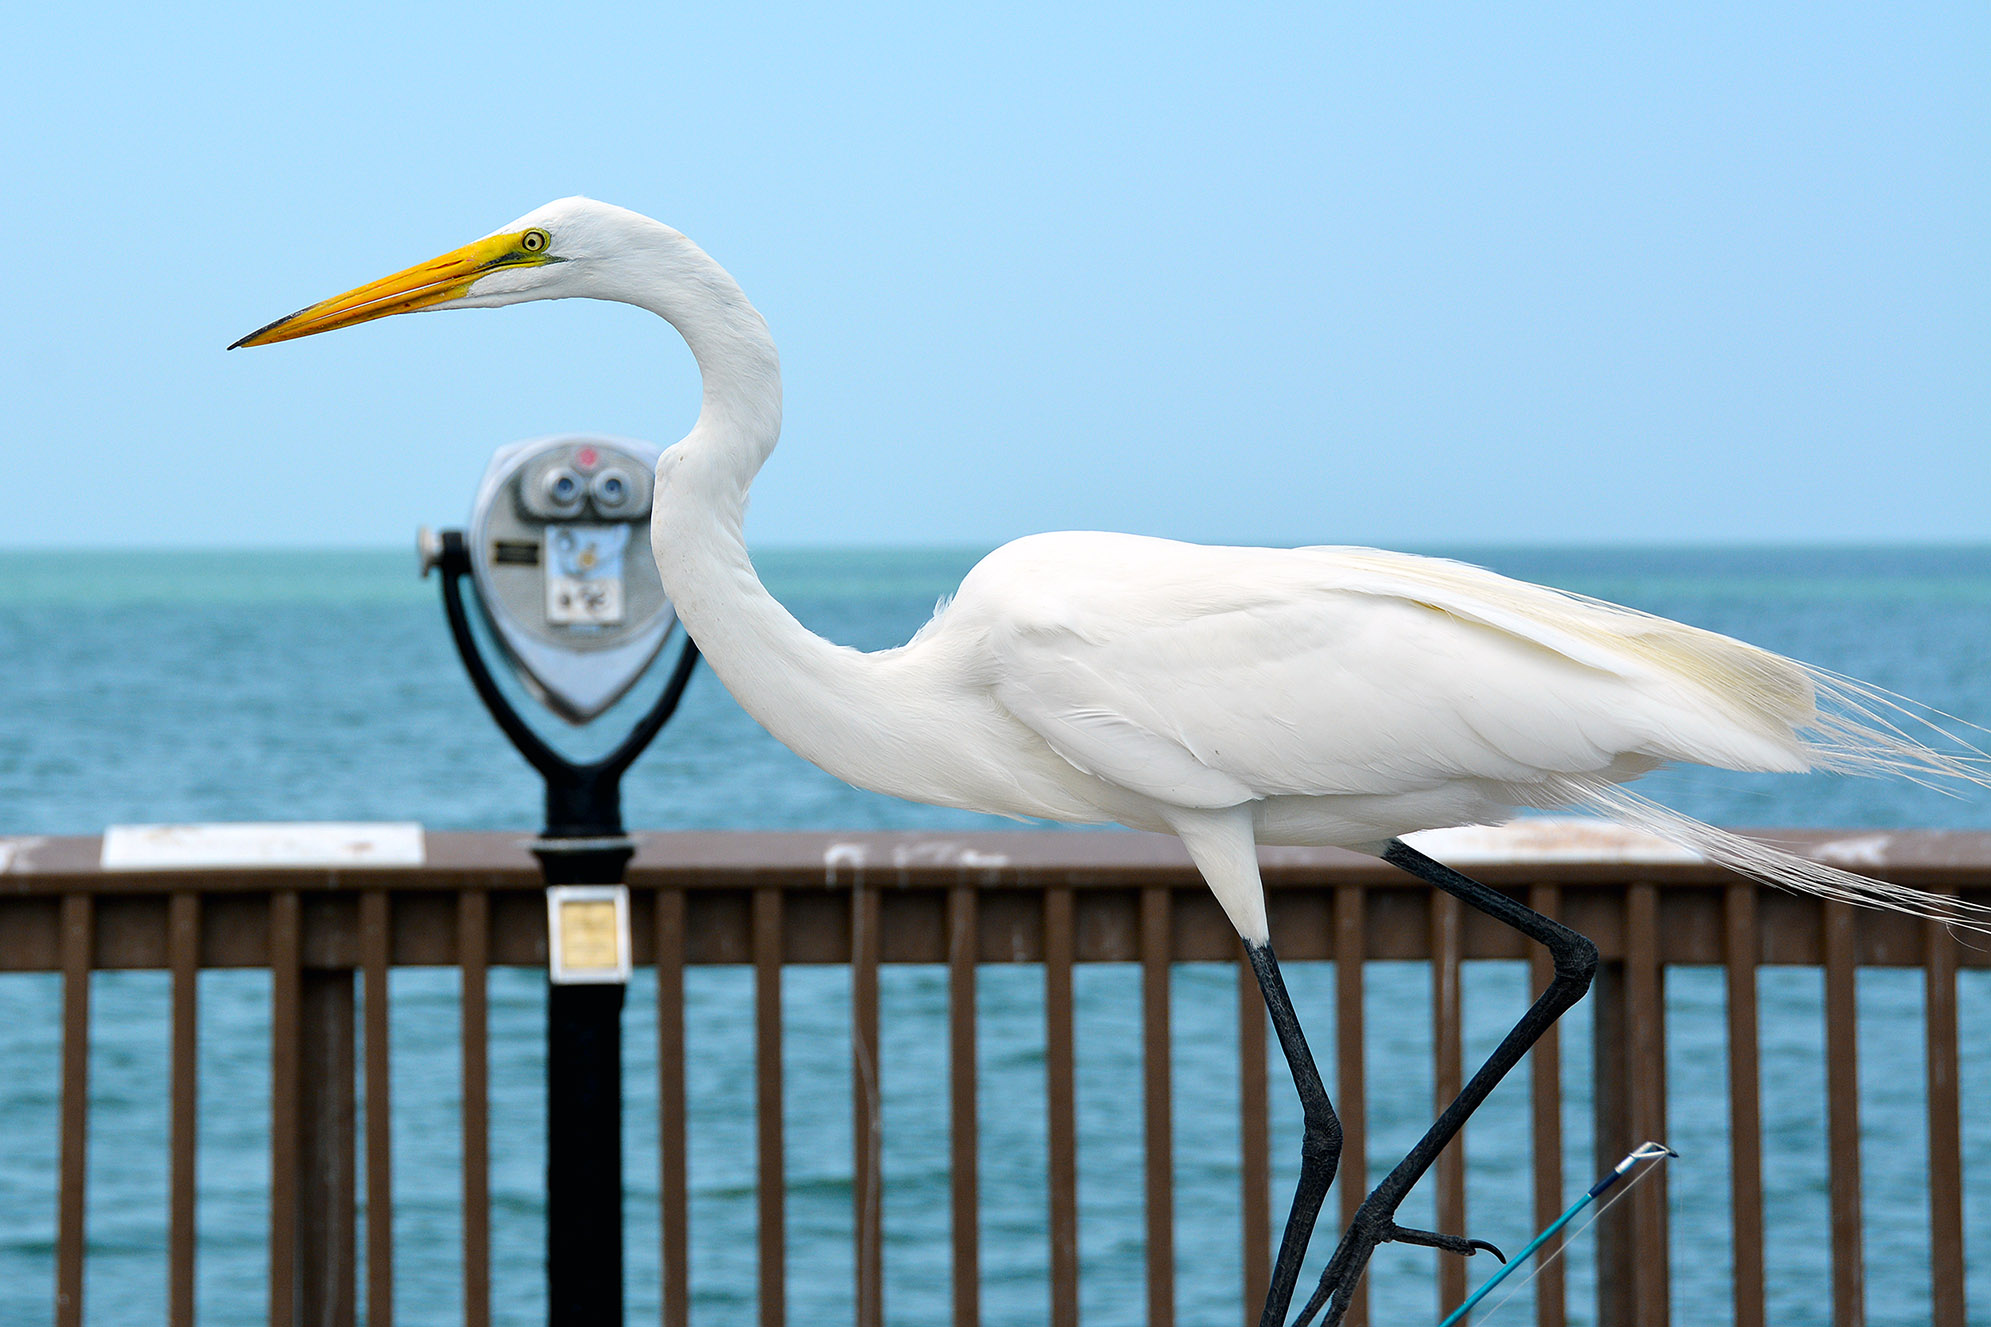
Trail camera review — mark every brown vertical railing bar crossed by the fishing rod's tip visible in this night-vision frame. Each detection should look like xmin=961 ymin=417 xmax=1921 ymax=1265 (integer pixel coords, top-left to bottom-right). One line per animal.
xmin=1624 ymin=881 xmax=1672 ymax=1327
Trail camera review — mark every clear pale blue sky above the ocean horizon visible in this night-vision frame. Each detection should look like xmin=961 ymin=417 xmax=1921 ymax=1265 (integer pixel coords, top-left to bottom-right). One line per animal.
xmin=0 ymin=4 xmax=1991 ymax=548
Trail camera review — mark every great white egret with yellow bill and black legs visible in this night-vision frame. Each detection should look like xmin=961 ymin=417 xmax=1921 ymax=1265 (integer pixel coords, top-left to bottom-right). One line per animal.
xmin=231 ymin=197 xmax=1983 ymax=1327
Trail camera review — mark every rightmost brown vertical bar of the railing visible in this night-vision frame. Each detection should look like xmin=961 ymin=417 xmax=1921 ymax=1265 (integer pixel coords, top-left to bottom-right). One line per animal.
xmin=1921 ymin=904 xmax=1967 ymax=1327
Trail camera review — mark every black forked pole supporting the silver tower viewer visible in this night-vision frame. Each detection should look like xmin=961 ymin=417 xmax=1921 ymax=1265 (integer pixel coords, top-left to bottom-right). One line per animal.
xmin=438 ymin=530 xmax=699 ymax=1327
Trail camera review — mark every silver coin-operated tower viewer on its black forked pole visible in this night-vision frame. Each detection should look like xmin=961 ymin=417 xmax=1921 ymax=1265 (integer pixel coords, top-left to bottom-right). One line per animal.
xmin=420 ymin=436 xmax=699 ymax=1327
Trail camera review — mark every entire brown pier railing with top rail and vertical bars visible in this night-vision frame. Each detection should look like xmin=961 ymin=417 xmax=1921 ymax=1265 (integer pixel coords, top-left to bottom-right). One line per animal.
xmin=0 ymin=833 xmax=1991 ymax=1327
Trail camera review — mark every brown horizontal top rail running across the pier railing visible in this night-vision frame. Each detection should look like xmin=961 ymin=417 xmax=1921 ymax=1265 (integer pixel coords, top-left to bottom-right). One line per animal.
xmin=0 ymin=823 xmax=1991 ymax=972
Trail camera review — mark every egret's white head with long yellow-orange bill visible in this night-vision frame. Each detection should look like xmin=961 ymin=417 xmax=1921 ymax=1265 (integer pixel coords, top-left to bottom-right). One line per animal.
xmin=229 ymin=197 xmax=661 ymax=351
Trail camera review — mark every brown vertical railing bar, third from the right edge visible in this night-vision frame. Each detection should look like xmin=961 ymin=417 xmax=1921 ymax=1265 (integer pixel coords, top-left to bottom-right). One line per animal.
xmin=1722 ymin=881 xmax=1766 ymax=1327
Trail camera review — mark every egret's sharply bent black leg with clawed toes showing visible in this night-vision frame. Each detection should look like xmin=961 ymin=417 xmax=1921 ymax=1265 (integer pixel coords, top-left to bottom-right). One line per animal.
xmin=1294 ymin=839 xmax=1597 ymax=1327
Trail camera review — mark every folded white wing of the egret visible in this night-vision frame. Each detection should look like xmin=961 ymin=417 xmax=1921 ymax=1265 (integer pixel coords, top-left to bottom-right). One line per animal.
xmin=950 ymin=534 xmax=1816 ymax=807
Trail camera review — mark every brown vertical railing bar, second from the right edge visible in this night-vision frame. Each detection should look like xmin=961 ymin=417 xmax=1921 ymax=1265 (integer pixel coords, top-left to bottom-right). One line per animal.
xmin=1822 ymin=903 xmax=1866 ymax=1327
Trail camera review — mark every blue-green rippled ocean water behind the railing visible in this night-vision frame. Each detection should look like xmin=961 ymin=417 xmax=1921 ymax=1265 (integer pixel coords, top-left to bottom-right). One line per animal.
xmin=0 ymin=548 xmax=1991 ymax=1327
